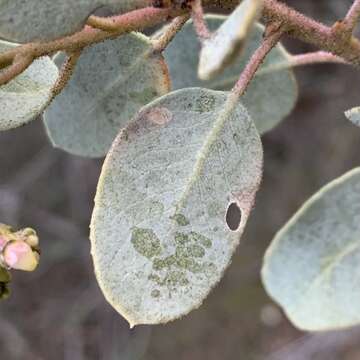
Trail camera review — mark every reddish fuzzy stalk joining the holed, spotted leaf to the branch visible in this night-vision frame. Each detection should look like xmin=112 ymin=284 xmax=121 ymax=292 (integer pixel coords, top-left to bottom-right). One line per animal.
xmin=231 ymin=24 xmax=284 ymax=102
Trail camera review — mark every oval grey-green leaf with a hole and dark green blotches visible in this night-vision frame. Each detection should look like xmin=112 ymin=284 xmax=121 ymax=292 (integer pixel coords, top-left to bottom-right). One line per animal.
xmin=90 ymin=88 xmax=262 ymax=326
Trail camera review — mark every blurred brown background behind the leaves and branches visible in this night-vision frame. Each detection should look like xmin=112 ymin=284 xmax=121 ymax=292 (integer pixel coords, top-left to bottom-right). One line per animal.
xmin=0 ymin=0 xmax=360 ymax=360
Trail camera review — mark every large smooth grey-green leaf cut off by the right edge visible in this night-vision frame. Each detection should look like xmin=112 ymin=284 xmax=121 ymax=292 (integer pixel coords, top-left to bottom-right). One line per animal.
xmin=262 ymin=168 xmax=360 ymax=331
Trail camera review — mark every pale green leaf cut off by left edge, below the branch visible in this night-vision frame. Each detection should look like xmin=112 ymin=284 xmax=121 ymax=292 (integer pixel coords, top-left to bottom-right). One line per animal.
xmin=0 ymin=41 xmax=58 ymax=131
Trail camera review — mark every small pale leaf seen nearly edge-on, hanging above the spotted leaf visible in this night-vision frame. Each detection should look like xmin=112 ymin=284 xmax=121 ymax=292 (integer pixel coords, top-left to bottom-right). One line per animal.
xmin=198 ymin=0 xmax=263 ymax=80
